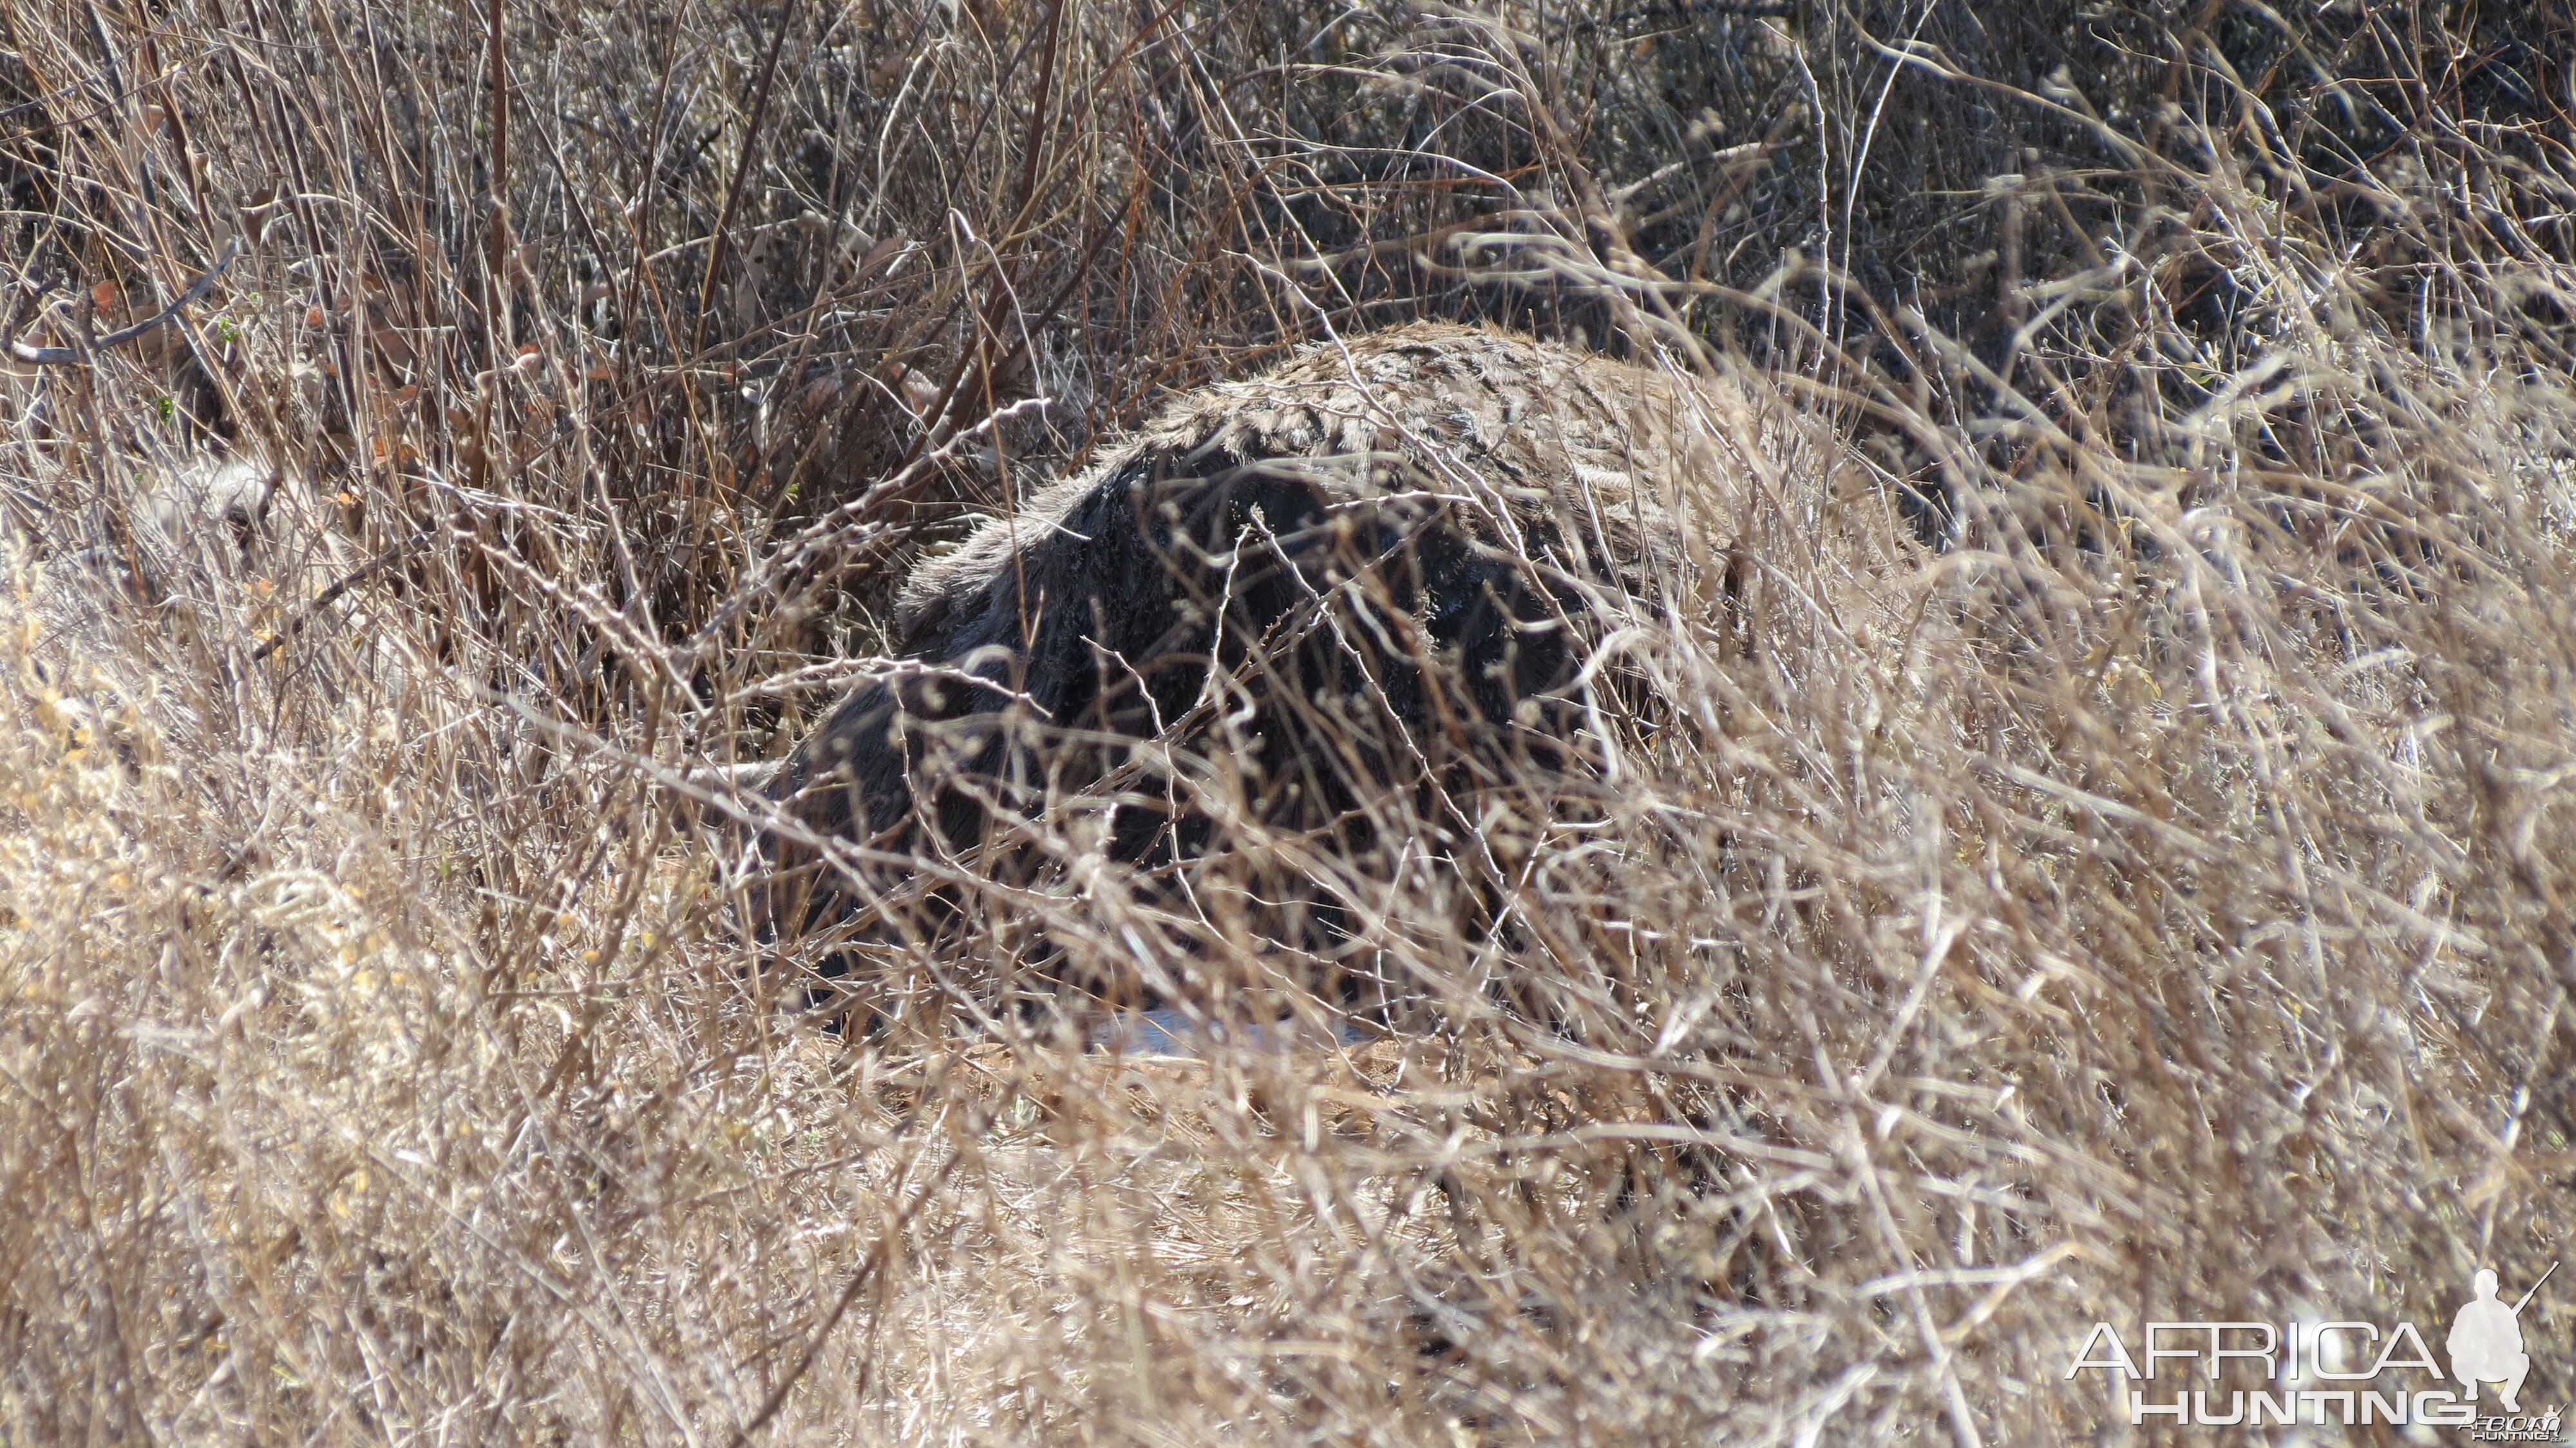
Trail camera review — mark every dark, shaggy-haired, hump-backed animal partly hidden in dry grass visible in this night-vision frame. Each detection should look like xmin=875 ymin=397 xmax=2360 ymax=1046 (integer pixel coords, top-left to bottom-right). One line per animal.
xmin=760 ymin=325 xmax=1896 ymax=1020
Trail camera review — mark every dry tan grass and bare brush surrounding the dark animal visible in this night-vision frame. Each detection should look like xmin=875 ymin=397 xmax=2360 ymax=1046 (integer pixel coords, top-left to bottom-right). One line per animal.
xmin=0 ymin=0 xmax=2576 ymax=1445
